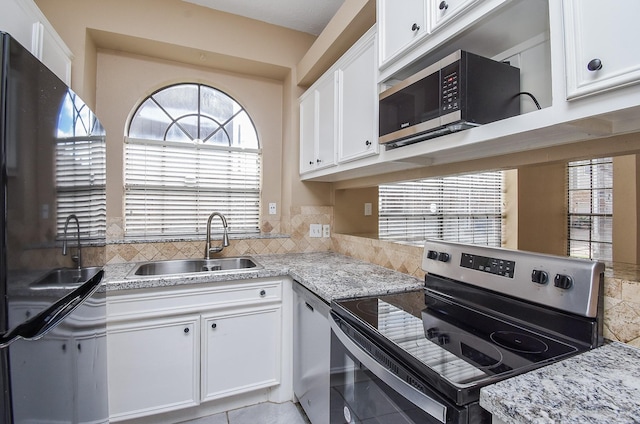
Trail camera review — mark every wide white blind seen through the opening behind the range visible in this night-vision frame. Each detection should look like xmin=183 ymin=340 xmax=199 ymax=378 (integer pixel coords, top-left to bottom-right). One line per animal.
xmin=378 ymin=172 xmax=502 ymax=246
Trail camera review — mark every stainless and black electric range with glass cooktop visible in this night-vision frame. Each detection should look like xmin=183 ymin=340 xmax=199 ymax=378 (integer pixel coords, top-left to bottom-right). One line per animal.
xmin=330 ymin=240 xmax=604 ymax=424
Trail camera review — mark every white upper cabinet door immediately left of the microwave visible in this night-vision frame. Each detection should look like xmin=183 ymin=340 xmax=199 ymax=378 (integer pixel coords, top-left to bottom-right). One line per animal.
xmin=338 ymin=38 xmax=378 ymax=162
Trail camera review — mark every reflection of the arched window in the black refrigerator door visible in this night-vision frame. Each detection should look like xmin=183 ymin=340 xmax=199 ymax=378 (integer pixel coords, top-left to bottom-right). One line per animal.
xmin=55 ymin=90 xmax=107 ymax=240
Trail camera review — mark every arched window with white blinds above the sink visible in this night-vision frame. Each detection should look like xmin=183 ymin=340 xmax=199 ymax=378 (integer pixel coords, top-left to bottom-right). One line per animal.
xmin=125 ymin=83 xmax=261 ymax=237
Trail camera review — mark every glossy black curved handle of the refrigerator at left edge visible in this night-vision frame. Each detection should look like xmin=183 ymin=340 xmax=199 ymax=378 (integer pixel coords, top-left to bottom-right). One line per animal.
xmin=0 ymin=270 xmax=104 ymax=349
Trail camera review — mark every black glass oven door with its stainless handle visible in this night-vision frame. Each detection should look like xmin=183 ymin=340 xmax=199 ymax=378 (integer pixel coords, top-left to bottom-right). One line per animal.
xmin=329 ymin=313 xmax=476 ymax=424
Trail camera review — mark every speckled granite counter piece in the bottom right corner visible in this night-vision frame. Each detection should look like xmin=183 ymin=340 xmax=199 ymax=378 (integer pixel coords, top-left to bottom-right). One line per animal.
xmin=480 ymin=342 xmax=640 ymax=424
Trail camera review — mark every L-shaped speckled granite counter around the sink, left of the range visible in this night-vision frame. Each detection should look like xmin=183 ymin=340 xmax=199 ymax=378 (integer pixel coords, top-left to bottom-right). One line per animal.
xmin=105 ymin=252 xmax=424 ymax=302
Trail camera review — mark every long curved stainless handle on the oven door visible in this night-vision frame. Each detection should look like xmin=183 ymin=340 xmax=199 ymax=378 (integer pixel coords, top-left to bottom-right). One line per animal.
xmin=329 ymin=317 xmax=447 ymax=423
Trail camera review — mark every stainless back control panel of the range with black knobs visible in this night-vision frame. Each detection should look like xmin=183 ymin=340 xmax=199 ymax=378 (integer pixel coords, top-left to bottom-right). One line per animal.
xmin=422 ymin=240 xmax=604 ymax=316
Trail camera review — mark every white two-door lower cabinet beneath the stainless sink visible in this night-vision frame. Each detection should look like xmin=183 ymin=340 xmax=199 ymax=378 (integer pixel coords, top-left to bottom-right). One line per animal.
xmin=107 ymin=279 xmax=282 ymax=422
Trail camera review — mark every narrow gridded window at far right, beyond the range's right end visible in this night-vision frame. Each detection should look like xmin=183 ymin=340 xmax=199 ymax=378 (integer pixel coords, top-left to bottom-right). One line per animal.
xmin=567 ymin=158 xmax=613 ymax=261
